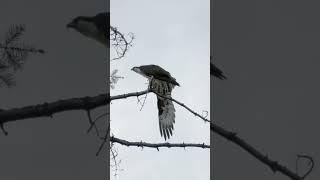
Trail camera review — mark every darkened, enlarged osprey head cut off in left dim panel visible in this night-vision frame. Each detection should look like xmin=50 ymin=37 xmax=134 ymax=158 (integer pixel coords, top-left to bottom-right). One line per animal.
xmin=67 ymin=12 xmax=110 ymax=47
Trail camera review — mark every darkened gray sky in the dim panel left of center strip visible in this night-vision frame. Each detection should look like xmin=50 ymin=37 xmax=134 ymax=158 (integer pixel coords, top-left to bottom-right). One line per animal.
xmin=0 ymin=0 xmax=109 ymax=180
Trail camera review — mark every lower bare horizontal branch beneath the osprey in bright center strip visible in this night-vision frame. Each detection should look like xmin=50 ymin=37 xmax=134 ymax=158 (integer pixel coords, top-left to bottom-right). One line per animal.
xmin=110 ymin=136 xmax=210 ymax=151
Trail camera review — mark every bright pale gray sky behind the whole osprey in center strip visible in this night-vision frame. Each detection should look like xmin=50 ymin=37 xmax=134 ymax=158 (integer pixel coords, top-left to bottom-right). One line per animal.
xmin=111 ymin=0 xmax=210 ymax=180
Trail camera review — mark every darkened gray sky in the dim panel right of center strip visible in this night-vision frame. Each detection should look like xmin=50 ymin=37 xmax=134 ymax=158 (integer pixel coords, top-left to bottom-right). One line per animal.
xmin=211 ymin=0 xmax=320 ymax=180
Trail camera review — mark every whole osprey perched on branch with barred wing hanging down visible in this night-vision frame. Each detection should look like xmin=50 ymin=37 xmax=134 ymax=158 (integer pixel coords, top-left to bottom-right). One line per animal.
xmin=131 ymin=65 xmax=180 ymax=140
